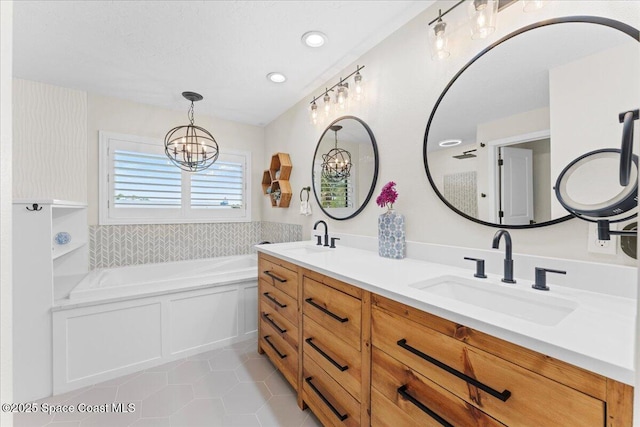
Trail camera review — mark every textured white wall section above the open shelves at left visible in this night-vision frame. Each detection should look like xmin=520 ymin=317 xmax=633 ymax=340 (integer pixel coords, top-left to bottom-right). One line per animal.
xmin=13 ymin=79 xmax=87 ymax=202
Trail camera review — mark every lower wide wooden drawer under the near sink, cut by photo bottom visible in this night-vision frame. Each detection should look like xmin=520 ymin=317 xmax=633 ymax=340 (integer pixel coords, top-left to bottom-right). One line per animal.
xmin=371 ymin=348 xmax=504 ymax=427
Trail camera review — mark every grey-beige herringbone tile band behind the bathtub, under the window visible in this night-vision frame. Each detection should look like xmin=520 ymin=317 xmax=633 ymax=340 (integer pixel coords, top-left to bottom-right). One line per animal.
xmin=89 ymin=221 xmax=302 ymax=269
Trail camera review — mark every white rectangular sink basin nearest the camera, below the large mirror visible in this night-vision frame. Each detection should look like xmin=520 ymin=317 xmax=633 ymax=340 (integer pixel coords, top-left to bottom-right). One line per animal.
xmin=409 ymin=275 xmax=578 ymax=326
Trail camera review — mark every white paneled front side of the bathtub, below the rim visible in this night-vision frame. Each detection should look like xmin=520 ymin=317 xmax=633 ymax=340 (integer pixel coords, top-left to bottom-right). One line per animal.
xmin=53 ymin=280 xmax=258 ymax=394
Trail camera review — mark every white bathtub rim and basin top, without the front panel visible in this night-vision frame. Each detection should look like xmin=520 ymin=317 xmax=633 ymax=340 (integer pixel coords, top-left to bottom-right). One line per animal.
xmin=69 ymin=255 xmax=258 ymax=302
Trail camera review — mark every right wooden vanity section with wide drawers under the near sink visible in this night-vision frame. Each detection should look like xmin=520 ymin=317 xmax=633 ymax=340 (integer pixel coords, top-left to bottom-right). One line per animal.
xmin=371 ymin=295 xmax=633 ymax=427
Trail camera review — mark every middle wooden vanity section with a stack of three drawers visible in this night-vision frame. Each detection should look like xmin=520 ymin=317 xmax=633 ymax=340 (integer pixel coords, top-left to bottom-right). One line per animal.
xmin=300 ymin=270 xmax=371 ymax=427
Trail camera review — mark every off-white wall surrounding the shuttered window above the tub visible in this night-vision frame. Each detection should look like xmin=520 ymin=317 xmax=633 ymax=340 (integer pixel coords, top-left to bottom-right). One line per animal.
xmin=84 ymin=94 xmax=268 ymax=225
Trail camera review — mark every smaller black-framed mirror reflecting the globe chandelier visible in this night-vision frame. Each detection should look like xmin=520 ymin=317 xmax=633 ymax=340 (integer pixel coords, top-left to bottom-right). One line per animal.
xmin=311 ymin=116 xmax=378 ymax=220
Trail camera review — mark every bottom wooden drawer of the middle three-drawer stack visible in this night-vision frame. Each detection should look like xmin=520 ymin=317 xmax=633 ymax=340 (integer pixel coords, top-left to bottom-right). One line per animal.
xmin=302 ymin=355 xmax=360 ymax=427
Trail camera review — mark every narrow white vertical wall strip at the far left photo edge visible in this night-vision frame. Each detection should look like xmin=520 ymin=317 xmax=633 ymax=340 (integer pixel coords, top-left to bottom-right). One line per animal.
xmin=0 ymin=1 xmax=13 ymax=427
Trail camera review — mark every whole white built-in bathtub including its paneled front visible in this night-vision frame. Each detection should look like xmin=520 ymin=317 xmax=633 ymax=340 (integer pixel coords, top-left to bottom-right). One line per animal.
xmin=52 ymin=255 xmax=258 ymax=394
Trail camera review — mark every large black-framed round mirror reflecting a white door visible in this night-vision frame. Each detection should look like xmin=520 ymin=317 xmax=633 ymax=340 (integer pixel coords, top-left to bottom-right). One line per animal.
xmin=423 ymin=17 xmax=640 ymax=228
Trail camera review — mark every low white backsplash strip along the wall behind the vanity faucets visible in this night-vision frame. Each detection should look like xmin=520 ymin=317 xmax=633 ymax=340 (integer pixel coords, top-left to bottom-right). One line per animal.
xmin=328 ymin=229 xmax=638 ymax=299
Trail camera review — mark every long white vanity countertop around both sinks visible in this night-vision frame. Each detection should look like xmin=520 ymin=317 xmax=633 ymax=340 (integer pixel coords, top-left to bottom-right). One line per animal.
xmin=256 ymin=241 xmax=636 ymax=385
